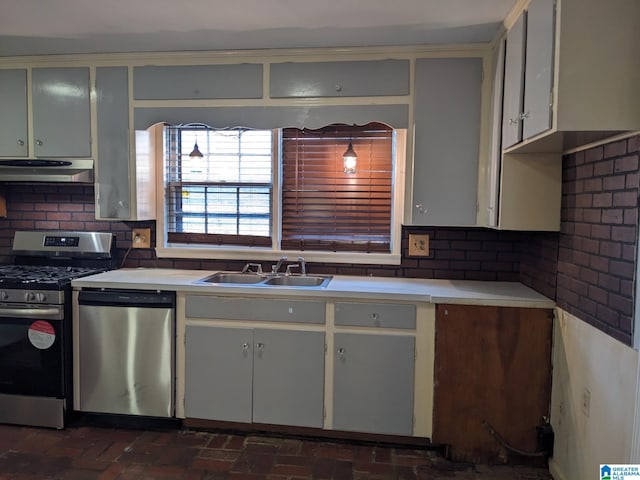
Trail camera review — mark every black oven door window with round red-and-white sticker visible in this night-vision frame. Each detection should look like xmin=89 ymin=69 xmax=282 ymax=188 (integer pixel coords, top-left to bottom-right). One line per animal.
xmin=0 ymin=317 xmax=64 ymax=398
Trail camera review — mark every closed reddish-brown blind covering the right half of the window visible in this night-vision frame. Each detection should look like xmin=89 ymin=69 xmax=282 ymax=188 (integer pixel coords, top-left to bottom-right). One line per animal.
xmin=282 ymin=123 xmax=393 ymax=252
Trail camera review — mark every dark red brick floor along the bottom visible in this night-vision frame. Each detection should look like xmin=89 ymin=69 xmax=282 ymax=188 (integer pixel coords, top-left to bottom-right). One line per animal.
xmin=0 ymin=425 xmax=551 ymax=480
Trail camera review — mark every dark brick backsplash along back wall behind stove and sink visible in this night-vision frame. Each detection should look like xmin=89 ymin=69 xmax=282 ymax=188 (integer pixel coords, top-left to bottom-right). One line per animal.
xmin=0 ymin=185 xmax=527 ymax=281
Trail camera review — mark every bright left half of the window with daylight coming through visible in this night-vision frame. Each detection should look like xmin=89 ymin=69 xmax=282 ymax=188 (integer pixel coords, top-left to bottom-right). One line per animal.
xmin=166 ymin=126 xmax=273 ymax=246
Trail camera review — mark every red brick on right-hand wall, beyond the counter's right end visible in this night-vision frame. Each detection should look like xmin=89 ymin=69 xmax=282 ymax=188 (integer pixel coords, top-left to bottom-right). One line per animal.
xmin=556 ymin=136 xmax=640 ymax=345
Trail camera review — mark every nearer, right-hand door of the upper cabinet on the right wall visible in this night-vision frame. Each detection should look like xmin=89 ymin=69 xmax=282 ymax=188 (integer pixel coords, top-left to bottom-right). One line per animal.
xmin=522 ymin=0 xmax=556 ymax=140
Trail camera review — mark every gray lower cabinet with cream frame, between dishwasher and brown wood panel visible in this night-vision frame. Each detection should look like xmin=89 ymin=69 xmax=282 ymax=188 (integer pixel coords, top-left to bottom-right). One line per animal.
xmin=177 ymin=294 xmax=435 ymax=437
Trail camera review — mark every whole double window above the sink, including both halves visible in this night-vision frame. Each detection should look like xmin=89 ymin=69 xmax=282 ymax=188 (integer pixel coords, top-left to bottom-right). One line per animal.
xmin=159 ymin=123 xmax=404 ymax=263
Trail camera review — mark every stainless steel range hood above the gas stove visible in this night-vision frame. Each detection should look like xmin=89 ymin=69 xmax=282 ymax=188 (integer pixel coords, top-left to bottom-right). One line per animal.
xmin=0 ymin=158 xmax=93 ymax=184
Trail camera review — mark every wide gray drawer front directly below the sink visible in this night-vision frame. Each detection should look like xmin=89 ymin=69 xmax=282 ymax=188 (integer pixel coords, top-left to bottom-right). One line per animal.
xmin=186 ymin=295 xmax=325 ymax=324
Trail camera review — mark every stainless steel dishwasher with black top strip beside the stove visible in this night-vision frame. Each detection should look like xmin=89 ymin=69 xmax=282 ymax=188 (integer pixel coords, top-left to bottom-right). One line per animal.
xmin=76 ymin=289 xmax=175 ymax=417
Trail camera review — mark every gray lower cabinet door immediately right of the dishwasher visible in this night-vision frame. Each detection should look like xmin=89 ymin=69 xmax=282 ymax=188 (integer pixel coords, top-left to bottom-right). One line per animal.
xmin=184 ymin=325 xmax=253 ymax=423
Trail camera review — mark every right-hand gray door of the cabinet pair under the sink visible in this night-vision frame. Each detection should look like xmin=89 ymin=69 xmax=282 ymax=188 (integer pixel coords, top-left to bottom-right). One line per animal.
xmin=253 ymin=329 xmax=325 ymax=428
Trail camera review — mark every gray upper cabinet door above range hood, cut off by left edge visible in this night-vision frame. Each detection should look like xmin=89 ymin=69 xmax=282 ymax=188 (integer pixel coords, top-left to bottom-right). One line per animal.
xmin=0 ymin=69 xmax=29 ymax=157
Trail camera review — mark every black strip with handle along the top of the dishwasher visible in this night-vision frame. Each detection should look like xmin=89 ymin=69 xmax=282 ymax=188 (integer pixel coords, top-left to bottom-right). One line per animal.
xmin=78 ymin=290 xmax=176 ymax=308
